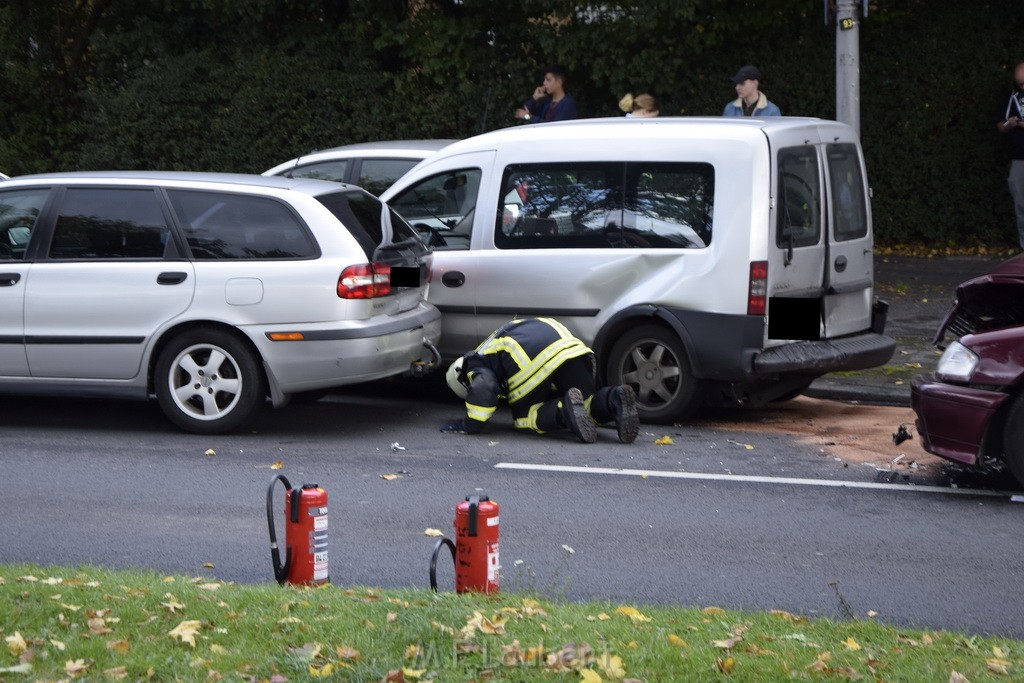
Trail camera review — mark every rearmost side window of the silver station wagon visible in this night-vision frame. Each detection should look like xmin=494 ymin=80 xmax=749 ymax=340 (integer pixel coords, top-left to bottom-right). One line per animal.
xmin=167 ymin=189 xmax=318 ymax=260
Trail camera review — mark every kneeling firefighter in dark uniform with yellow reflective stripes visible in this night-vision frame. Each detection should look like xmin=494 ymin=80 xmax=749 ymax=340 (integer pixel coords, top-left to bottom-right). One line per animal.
xmin=441 ymin=317 xmax=640 ymax=443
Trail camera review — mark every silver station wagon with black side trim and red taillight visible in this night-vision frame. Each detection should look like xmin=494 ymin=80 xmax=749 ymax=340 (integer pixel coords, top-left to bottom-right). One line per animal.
xmin=0 ymin=172 xmax=440 ymax=434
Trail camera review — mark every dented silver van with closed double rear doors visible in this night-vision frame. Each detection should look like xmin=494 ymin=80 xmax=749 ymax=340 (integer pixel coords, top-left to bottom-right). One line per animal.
xmin=381 ymin=118 xmax=895 ymax=423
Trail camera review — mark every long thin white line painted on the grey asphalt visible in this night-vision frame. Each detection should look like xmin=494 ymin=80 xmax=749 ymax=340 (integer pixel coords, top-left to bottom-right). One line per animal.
xmin=495 ymin=463 xmax=1014 ymax=498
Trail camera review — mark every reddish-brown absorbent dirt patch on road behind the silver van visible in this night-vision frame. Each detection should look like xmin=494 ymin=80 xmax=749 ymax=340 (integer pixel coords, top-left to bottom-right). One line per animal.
xmin=689 ymin=396 xmax=945 ymax=469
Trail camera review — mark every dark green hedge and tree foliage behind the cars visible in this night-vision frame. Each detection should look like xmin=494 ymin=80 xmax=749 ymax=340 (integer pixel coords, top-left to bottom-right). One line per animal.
xmin=0 ymin=0 xmax=1024 ymax=246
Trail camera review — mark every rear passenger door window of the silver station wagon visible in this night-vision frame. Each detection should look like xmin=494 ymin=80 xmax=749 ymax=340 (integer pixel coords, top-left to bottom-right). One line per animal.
xmin=48 ymin=187 xmax=170 ymax=260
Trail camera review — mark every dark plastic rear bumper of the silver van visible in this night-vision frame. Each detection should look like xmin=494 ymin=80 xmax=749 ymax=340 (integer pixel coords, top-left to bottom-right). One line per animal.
xmin=754 ymin=332 xmax=896 ymax=375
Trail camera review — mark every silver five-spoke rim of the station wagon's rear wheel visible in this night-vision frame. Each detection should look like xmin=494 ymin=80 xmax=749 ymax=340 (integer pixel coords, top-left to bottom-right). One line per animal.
xmin=167 ymin=344 xmax=243 ymax=421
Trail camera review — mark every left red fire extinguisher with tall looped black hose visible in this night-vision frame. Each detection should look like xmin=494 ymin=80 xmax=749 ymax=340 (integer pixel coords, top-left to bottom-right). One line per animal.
xmin=266 ymin=474 xmax=331 ymax=586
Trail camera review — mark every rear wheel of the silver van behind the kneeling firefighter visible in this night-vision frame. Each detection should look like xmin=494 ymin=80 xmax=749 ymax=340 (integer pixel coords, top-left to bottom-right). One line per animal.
xmin=605 ymin=325 xmax=705 ymax=424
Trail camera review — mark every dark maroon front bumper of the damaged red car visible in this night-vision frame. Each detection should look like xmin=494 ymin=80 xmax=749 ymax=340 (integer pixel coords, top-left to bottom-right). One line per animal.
xmin=910 ymin=375 xmax=1010 ymax=465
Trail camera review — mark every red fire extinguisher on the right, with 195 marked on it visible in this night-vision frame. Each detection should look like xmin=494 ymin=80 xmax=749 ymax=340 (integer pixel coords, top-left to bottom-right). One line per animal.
xmin=430 ymin=496 xmax=501 ymax=593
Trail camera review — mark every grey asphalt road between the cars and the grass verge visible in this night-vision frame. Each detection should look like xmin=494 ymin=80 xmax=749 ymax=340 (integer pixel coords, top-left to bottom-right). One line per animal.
xmin=0 ymin=383 xmax=1024 ymax=637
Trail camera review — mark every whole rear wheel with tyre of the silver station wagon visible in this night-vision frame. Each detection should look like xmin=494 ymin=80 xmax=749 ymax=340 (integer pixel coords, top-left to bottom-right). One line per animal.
xmin=154 ymin=328 xmax=266 ymax=434
